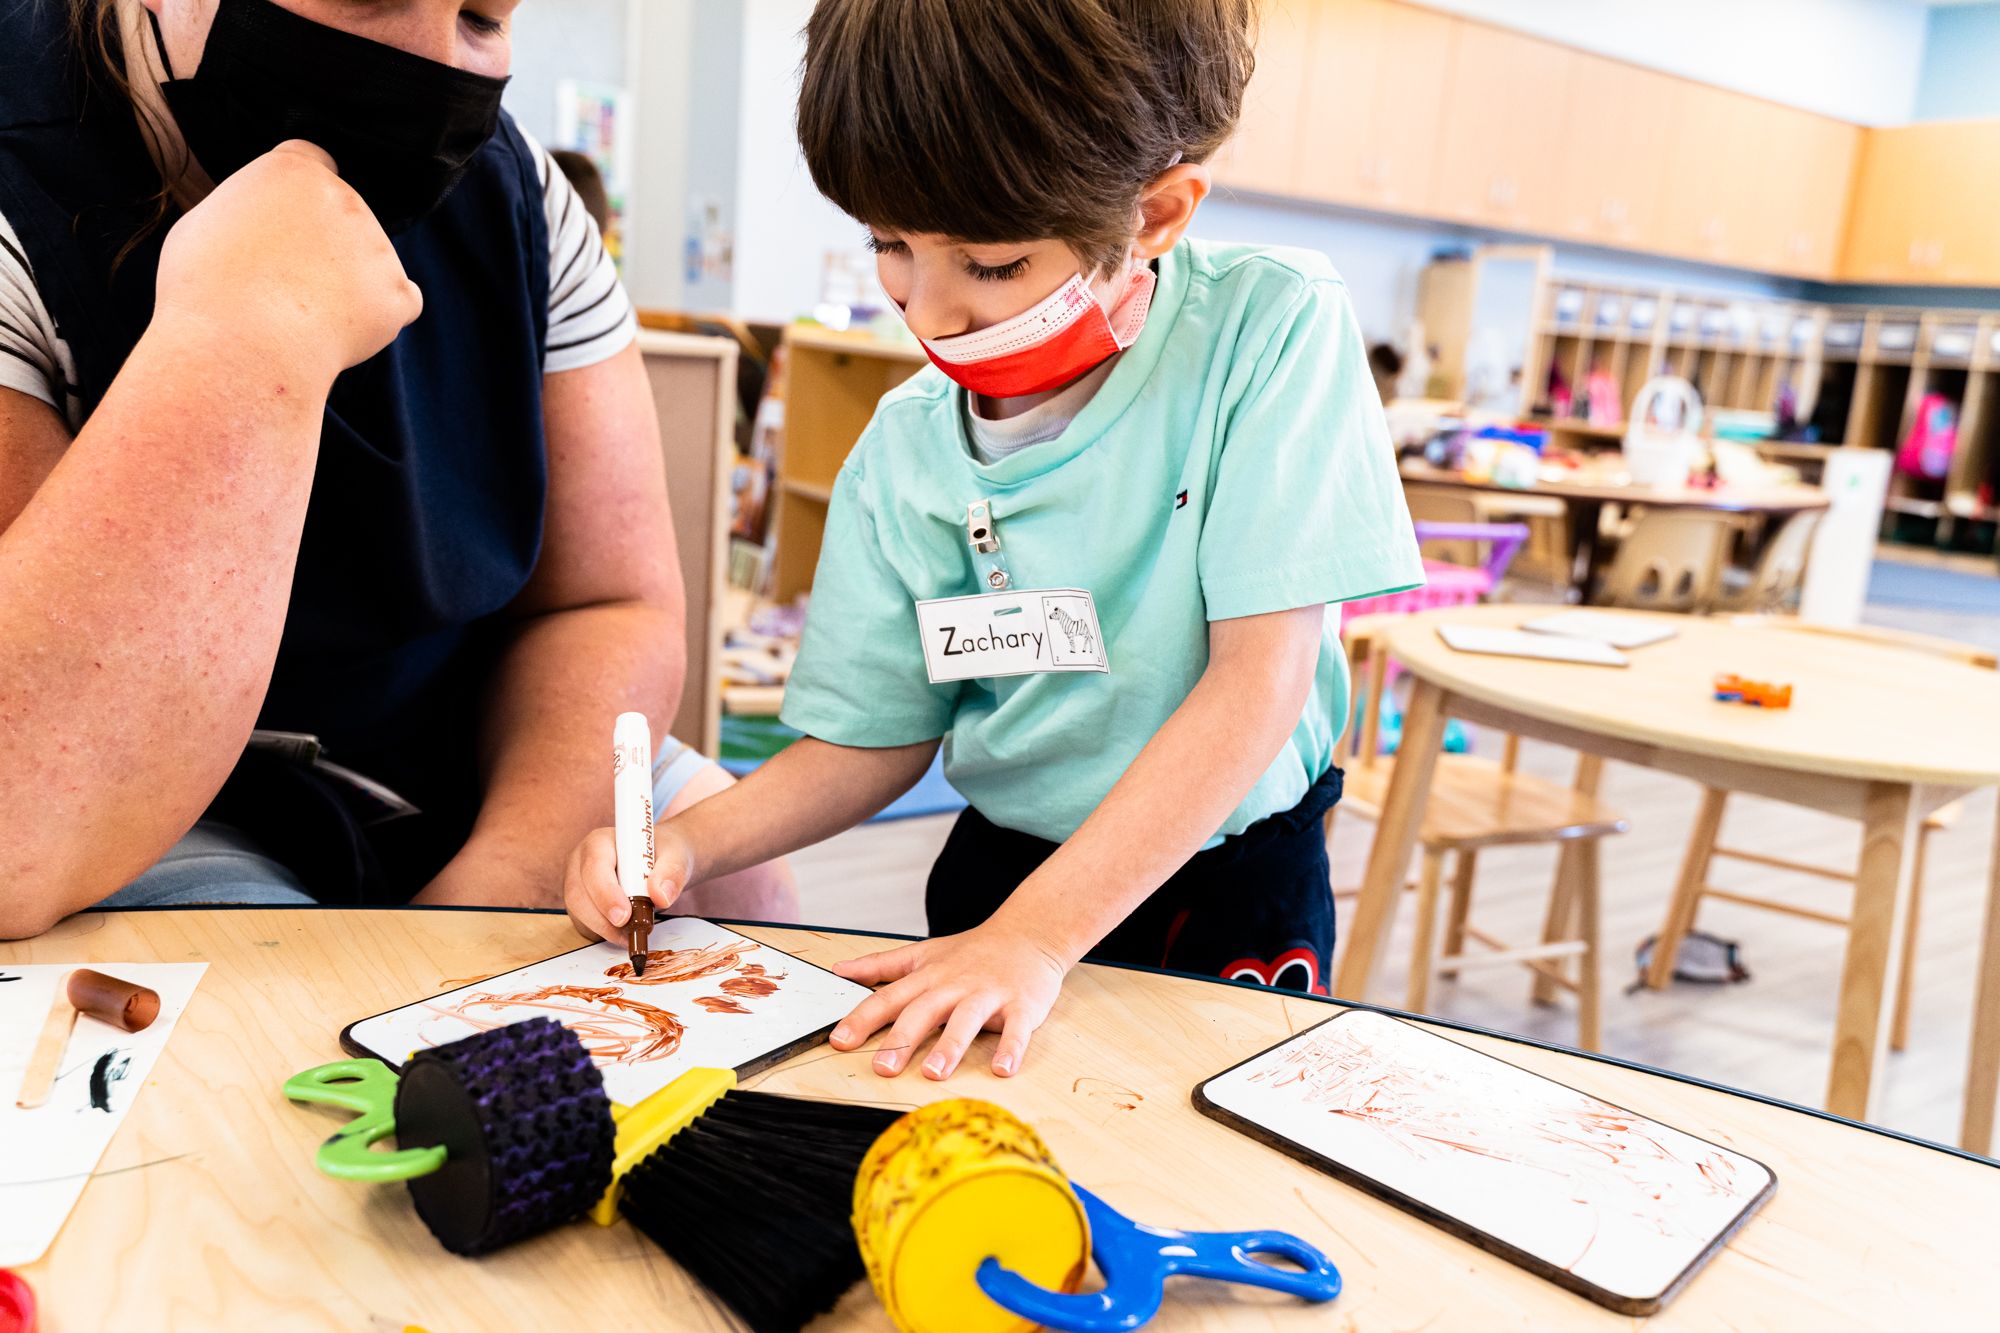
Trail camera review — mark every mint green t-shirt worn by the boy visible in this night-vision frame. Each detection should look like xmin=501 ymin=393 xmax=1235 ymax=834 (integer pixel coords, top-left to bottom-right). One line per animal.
xmin=782 ymin=240 xmax=1424 ymax=843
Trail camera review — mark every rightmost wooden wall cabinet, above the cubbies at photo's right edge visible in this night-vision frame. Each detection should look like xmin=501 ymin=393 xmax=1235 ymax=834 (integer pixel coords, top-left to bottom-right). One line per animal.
xmin=1840 ymin=120 xmax=2000 ymax=284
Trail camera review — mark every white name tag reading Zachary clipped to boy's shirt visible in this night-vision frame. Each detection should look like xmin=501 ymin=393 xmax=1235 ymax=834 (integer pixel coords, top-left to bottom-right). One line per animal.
xmin=916 ymin=588 xmax=1112 ymax=685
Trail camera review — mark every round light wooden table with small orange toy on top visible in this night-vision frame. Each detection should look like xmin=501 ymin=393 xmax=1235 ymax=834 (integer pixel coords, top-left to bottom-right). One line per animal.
xmin=1334 ymin=604 xmax=2000 ymax=1153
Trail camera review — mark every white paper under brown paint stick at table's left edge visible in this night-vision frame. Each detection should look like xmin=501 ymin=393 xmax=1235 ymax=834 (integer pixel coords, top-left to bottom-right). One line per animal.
xmin=0 ymin=963 xmax=208 ymax=1269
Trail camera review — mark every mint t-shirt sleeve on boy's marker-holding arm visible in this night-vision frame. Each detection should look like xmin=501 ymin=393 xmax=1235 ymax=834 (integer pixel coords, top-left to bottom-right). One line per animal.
xmin=778 ymin=466 xmax=958 ymax=749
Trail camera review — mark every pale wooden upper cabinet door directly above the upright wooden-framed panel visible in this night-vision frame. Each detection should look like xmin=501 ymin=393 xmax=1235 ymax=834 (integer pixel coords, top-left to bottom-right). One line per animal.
xmin=1430 ymin=24 xmax=1580 ymax=232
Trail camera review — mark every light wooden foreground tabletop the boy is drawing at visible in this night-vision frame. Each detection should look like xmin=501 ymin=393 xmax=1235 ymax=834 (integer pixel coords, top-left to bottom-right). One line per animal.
xmin=0 ymin=896 xmax=2000 ymax=1333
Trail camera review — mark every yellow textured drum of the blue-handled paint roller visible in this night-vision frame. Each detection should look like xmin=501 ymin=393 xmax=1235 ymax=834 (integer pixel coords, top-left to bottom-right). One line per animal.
xmin=854 ymin=1099 xmax=1090 ymax=1333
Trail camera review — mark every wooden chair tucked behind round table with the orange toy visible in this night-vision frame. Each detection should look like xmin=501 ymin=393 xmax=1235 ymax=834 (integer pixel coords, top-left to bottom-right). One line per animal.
xmin=1646 ymin=616 xmax=2000 ymax=1051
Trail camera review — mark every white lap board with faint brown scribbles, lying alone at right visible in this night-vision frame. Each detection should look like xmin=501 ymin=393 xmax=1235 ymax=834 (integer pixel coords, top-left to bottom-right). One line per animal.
xmin=1196 ymin=1009 xmax=1776 ymax=1315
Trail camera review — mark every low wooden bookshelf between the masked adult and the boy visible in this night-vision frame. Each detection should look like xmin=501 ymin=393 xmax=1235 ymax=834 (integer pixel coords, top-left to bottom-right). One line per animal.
xmin=770 ymin=324 xmax=924 ymax=602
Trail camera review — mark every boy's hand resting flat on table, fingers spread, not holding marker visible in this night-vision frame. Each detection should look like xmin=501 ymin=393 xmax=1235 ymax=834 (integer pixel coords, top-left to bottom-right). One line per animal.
xmin=832 ymin=917 xmax=1072 ymax=1079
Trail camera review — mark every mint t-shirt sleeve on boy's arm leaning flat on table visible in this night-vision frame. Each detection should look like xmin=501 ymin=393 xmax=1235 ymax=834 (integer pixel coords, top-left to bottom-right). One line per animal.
xmin=1200 ymin=280 xmax=1424 ymax=620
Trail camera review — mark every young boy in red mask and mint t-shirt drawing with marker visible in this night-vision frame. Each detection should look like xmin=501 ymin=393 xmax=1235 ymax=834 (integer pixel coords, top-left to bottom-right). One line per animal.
xmin=564 ymin=0 xmax=1422 ymax=1079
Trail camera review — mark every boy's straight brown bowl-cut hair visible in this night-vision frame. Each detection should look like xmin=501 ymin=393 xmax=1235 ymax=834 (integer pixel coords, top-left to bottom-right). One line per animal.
xmin=798 ymin=0 xmax=1256 ymax=268
